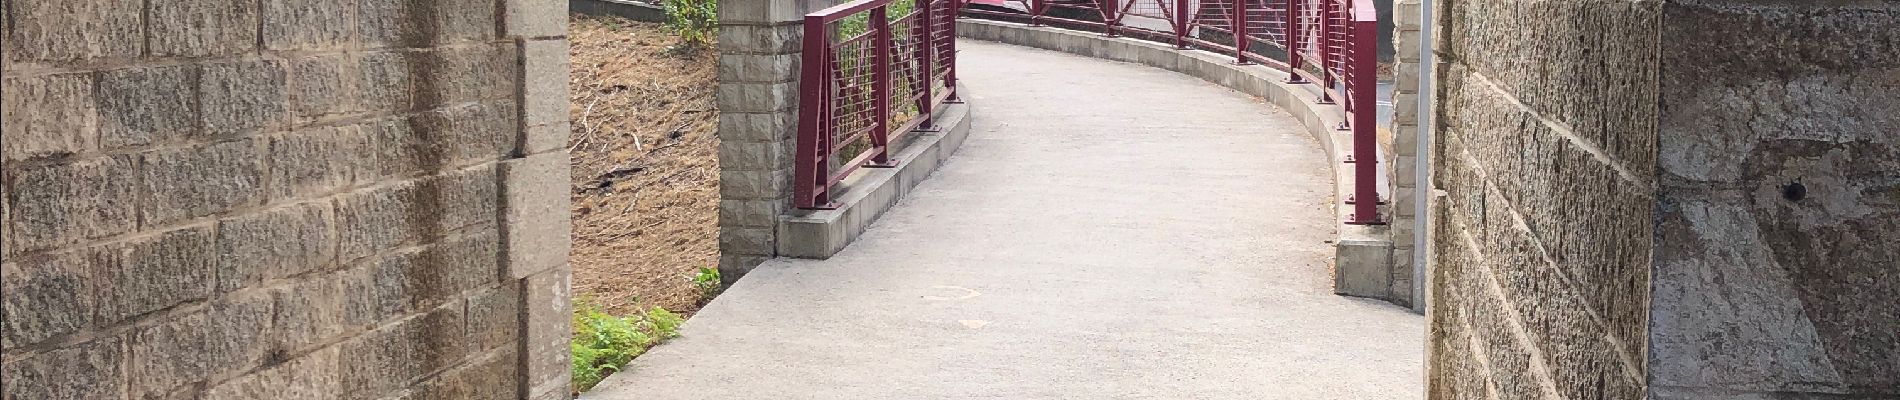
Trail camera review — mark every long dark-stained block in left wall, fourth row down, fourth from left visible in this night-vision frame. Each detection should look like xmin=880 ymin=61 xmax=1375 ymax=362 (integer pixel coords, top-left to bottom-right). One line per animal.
xmin=336 ymin=165 xmax=498 ymax=262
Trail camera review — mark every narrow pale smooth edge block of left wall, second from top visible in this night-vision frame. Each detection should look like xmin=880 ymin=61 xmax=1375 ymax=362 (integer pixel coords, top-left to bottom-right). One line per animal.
xmin=521 ymin=40 xmax=568 ymax=127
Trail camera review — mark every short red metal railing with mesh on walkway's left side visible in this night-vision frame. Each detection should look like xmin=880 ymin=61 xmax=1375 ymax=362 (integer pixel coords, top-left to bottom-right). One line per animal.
xmin=792 ymin=0 xmax=958 ymax=209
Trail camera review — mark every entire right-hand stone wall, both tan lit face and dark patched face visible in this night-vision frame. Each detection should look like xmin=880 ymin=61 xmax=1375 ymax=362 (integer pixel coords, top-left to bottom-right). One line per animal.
xmin=1429 ymin=0 xmax=1900 ymax=398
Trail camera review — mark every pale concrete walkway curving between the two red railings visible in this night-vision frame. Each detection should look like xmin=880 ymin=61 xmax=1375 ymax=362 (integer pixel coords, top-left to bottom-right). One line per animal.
xmin=583 ymin=40 xmax=1425 ymax=400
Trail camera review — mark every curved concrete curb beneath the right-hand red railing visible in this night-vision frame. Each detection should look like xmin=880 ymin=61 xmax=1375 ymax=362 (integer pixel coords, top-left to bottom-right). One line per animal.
xmin=958 ymin=19 xmax=1412 ymax=305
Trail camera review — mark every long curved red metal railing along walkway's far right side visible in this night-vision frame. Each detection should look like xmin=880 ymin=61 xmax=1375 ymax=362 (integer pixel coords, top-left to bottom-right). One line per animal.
xmin=961 ymin=0 xmax=1385 ymax=226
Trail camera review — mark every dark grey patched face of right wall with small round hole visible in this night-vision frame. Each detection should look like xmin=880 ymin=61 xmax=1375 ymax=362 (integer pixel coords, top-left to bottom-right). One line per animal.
xmin=1649 ymin=0 xmax=1900 ymax=400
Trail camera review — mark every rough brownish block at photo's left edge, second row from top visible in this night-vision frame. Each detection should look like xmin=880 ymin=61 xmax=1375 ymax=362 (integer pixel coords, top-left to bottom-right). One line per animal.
xmin=0 ymin=74 xmax=99 ymax=159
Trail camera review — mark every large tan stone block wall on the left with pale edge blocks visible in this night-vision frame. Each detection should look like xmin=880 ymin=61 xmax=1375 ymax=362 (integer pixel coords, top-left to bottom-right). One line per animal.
xmin=0 ymin=0 xmax=570 ymax=400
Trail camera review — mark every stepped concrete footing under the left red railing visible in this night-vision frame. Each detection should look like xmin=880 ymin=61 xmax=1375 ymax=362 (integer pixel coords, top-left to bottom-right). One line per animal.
xmin=779 ymin=97 xmax=971 ymax=258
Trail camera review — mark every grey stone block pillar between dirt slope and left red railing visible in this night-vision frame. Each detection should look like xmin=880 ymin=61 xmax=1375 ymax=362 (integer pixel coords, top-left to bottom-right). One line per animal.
xmin=716 ymin=0 xmax=834 ymax=282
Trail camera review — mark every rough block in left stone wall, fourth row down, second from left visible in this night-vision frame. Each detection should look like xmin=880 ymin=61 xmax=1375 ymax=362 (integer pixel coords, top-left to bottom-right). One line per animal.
xmin=99 ymin=226 xmax=217 ymax=324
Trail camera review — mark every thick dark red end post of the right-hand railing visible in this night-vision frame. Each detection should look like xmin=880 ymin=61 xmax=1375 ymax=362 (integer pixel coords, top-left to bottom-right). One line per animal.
xmin=1341 ymin=21 xmax=1385 ymax=226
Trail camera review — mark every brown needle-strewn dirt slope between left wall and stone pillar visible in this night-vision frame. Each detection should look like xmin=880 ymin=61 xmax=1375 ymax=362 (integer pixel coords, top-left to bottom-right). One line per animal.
xmin=568 ymin=17 xmax=718 ymax=313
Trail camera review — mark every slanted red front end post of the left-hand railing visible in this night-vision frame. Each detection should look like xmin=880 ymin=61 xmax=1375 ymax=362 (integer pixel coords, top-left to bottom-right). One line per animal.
xmin=792 ymin=15 xmax=830 ymax=209
